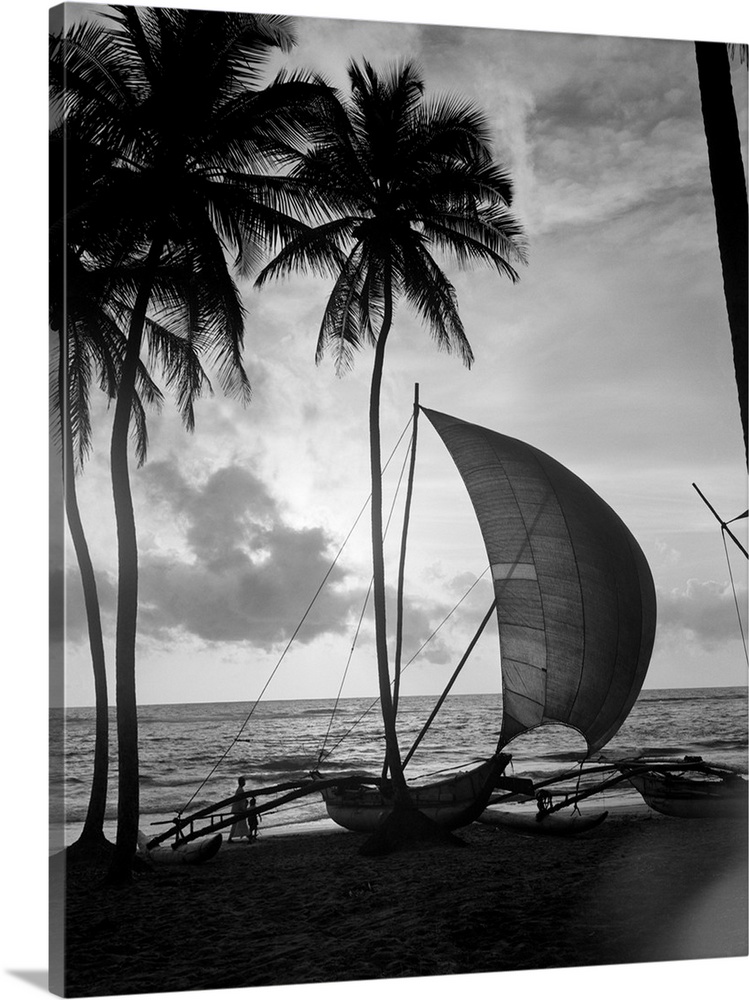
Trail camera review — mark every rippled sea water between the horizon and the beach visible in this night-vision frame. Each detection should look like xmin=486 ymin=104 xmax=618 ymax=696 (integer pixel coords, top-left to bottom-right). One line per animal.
xmin=50 ymin=688 xmax=747 ymax=850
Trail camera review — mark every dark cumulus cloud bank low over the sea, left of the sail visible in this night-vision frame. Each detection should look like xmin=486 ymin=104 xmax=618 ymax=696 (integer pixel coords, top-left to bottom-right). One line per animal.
xmin=55 ymin=461 xmax=450 ymax=663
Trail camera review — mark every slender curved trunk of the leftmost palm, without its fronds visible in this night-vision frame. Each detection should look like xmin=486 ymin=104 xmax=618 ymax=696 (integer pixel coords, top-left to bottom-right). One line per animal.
xmin=58 ymin=330 xmax=109 ymax=848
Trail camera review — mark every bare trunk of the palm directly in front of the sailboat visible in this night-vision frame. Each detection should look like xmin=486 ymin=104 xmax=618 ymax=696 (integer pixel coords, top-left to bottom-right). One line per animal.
xmin=369 ymin=271 xmax=410 ymax=805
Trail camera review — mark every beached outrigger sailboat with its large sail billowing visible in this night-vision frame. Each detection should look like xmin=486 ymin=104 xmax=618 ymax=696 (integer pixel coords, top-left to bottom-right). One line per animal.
xmin=148 ymin=398 xmax=656 ymax=849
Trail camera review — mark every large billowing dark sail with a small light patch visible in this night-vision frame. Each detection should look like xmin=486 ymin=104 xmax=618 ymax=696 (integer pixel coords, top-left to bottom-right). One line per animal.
xmin=423 ymin=409 xmax=656 ymax=752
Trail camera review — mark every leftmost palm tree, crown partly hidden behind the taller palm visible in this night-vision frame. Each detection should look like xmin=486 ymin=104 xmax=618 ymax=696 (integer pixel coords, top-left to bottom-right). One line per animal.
xmin=49 ymin=130 xmax=210 ymax=856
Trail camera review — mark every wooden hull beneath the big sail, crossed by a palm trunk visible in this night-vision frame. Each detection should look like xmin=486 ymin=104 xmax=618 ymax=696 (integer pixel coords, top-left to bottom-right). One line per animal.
xmin=320 ymin=754 xmax=511 ymax=833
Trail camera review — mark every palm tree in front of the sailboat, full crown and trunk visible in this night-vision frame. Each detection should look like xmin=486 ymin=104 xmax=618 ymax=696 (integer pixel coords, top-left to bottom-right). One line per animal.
xmin=256 ymin=56 xmax=525 ymax=836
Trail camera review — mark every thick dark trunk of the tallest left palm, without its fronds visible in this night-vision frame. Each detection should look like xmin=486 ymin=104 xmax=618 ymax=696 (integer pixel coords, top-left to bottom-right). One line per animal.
xmin=108 ymin=238 xmax=163 ymax=882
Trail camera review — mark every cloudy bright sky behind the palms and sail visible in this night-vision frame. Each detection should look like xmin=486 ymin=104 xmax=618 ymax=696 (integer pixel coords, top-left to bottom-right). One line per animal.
xmin=50 ymin=5 xmax=747 ymax=705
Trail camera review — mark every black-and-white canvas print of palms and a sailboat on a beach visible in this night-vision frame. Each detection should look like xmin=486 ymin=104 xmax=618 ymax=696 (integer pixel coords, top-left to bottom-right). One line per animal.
xmin=49 ymin=3 xmax=747 ymax=997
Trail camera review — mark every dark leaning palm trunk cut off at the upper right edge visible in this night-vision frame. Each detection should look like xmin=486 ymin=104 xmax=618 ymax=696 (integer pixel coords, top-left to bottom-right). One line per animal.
xmin=695 ymin=42 xmax=749 ymax=462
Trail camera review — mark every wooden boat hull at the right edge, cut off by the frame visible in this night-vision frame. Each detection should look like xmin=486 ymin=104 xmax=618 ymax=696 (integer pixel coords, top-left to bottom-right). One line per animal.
xmin=628 ymin=773 xmax=747 ymax=819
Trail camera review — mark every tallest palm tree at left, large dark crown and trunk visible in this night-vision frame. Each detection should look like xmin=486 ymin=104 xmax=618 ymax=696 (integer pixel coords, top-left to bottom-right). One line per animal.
xmin=52 ymin=7 xmax=319 ymax=881
